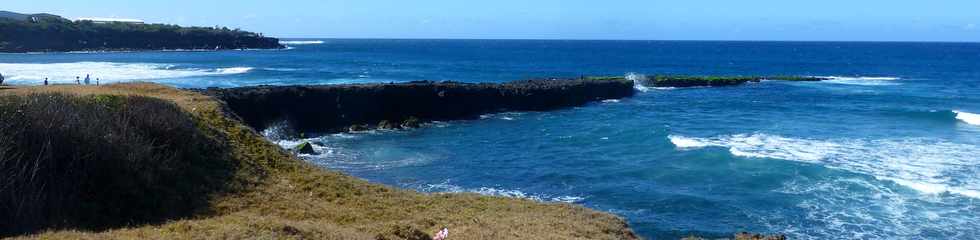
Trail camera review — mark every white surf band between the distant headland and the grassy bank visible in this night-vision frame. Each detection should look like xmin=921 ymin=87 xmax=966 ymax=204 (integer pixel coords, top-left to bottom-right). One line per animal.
xmin=0 ymin=62 xmax=252 ymax=85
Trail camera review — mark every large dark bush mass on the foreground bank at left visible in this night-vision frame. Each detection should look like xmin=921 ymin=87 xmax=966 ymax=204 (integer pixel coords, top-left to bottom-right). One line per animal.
xmin=0 ymin=94 xmax=234 ymax=237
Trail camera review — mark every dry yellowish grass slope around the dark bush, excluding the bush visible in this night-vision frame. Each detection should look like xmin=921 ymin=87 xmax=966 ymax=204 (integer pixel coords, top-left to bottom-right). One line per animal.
xmin=0 ymin=84 xmax=636 ymax=239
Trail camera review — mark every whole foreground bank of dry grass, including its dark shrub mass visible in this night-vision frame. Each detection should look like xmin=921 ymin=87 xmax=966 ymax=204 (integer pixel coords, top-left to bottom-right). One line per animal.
xmin=0 ymin=84 xmax=637 ymax=239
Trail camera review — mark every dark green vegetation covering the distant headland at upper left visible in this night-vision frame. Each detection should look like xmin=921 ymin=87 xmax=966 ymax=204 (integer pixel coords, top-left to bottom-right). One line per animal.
xmin=0 ymin=12 xmax=283 ymax=52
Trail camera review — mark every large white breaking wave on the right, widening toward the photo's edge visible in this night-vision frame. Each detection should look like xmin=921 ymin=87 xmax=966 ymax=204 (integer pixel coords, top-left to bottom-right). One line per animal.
xmin=669 ymin=134 xmax=980 ymax=198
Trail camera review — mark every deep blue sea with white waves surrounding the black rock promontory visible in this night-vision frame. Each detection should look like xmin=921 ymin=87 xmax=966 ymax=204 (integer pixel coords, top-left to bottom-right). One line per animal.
xmin=0 ymin=40 xmax=980 ymax=239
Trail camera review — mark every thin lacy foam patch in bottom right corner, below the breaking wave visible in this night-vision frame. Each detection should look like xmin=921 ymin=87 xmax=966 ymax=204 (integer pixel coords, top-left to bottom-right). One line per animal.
xmin=776 ymin=176 xmax=980 ymax=239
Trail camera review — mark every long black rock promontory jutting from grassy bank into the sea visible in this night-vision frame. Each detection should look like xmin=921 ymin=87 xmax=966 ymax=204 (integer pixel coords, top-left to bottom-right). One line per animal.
xmin=205 ymin=79 xmax=634 ymax=133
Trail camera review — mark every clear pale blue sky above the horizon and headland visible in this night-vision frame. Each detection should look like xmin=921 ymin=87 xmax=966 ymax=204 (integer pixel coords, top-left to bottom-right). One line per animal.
xmin=7 ymin=0 xmax=980 ymax=42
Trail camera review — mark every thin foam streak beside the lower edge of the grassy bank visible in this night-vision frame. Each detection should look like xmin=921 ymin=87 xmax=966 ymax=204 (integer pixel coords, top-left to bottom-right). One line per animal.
xmin=419 ymin=182 xmax=585 ymax=203
